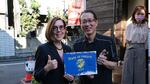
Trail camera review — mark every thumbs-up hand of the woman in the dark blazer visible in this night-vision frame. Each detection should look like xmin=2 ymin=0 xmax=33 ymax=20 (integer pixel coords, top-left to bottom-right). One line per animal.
xmin=44 ymin=55 xmax=58 ymax=72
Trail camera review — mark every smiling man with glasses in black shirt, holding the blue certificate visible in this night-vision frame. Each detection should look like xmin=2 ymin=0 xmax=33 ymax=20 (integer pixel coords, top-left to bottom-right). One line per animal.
xmin=74 ymin=10 xmax=118 ymax=84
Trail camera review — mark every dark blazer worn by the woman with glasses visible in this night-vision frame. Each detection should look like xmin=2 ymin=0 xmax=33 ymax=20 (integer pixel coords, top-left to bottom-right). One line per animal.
xmin=34 ymin=42 xmax=71 ymax=84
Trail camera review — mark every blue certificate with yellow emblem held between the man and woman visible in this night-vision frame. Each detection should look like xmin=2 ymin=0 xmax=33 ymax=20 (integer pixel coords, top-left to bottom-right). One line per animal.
xmin=64 ymin=51 xmax=97 ymax=76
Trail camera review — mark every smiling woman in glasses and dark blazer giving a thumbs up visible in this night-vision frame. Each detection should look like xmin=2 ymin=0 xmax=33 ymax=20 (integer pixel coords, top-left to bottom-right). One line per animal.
xmin=34 ymin=17 xmax=74 ymax=84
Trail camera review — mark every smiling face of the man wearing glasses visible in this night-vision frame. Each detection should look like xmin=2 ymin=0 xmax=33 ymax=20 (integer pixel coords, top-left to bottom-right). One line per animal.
xmin=80 ymin=12 xmax=98 ymax=35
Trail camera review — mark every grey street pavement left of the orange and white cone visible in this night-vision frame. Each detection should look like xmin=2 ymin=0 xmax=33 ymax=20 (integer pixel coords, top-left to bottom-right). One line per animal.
xmin=0 ymin=61 xmax=26 ymax=84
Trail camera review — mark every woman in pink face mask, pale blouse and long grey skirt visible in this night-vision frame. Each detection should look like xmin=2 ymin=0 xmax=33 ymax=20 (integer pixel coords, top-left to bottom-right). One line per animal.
xmin=122 ymin=6 xmax=148 ymax=84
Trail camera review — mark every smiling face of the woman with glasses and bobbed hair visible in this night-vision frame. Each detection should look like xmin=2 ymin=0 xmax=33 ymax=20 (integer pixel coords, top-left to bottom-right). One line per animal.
xmin=52 ymin=20 xmax=66 ymax=41
